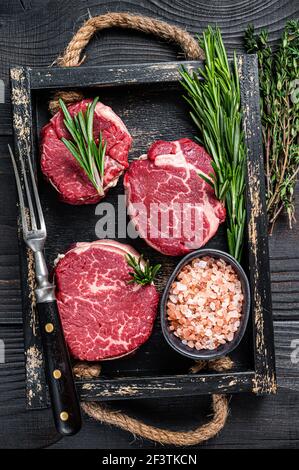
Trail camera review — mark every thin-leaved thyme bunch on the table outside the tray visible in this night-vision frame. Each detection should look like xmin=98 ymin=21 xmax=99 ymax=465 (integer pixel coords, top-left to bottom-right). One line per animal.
xmin=245 ymin=20 xmax=299 ymax=233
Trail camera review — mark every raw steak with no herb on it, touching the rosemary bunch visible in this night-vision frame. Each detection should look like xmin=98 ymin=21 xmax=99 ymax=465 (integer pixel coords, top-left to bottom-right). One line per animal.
xmin=124 ymin=139 xmax=225 ymax=256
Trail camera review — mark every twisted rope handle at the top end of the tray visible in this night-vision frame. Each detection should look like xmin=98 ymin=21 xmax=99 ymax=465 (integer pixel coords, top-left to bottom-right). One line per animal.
xmin=49 ymin=13 xmax=204 ymax=114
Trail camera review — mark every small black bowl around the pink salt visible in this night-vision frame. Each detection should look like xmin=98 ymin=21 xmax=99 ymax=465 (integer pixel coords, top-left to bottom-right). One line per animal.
xmin=160 ymin=248 xmax=250 ymax=360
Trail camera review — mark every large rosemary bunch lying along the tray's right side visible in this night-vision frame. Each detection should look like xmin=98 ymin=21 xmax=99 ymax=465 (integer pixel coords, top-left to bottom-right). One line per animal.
xmin=181 ymin=27 xmax=246 ymax=260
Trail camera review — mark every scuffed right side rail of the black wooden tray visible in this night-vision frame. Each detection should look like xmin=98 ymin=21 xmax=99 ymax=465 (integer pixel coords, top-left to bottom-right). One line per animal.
xmin=238 ymin=55 xmax=276 ymax=394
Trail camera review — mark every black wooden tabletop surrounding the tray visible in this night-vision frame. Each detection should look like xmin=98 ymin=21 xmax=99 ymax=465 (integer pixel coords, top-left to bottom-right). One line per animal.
xmin=0 ymin=0 xmax=299 ymax=449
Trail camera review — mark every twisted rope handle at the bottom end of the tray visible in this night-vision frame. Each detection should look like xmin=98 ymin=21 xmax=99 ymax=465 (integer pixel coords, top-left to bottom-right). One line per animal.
xmin=74 ymin=357 xmax=233 ymax=446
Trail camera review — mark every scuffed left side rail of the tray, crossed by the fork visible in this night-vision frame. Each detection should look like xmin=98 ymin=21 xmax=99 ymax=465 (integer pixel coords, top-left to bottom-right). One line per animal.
xmin=11 ymin=68 xmax=47 ymax=409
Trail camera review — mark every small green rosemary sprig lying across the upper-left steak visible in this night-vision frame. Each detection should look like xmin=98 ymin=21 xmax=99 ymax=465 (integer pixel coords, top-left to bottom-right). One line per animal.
xmin=59 ymin=97 xmax=106 ymax=196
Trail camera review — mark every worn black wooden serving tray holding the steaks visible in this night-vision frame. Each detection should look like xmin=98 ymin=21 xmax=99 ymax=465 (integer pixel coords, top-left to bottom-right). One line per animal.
xmin=11 ymin=56 xmax=276 ymax=408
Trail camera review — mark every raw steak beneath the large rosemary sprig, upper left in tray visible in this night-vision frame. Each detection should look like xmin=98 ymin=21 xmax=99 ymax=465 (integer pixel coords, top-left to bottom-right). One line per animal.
xmin=41 ymin=99 xmax=132 ymax=205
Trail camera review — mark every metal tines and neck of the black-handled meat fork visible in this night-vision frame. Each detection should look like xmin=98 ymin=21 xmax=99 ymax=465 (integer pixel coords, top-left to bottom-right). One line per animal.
xmin=8 ymin=145 xmax=55 ymax=302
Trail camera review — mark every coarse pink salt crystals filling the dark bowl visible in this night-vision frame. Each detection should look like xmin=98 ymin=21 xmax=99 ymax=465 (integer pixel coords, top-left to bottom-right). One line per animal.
xmin=167 ymin=256 xmax=244 ymax=350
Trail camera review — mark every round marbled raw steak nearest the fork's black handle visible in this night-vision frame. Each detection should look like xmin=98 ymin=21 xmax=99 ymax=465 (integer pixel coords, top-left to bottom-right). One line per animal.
xmin=54 ymin=240 xmax=159 ymax=361
